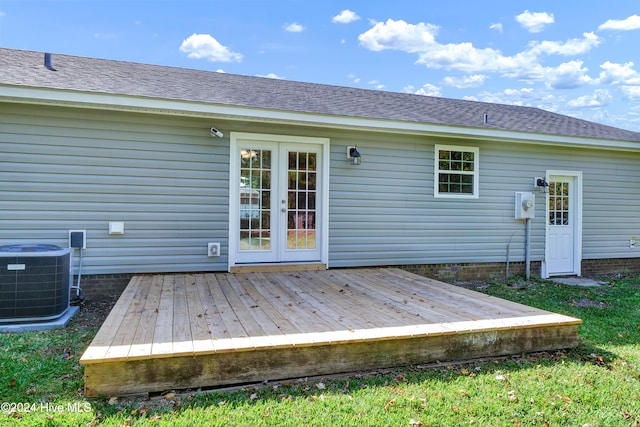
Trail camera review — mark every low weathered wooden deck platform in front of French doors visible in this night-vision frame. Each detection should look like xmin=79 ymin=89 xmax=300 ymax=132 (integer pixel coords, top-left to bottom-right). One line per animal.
xmin=80 ymin=268 xmax=580 ymax=397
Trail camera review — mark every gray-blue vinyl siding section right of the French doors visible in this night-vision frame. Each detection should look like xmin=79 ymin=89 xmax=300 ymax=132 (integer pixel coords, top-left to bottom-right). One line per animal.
xmin=330 ymin=135 xmax=640 ymax=267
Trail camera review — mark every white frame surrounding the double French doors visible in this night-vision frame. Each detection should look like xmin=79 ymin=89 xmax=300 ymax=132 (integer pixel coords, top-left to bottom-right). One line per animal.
xmin=228 ymin=132 xmax=330 ymax=271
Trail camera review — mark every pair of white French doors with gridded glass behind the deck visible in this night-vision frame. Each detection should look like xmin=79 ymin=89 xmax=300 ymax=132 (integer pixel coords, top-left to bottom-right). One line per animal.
xmin=229 ymin=134 xmax=326 ymax=265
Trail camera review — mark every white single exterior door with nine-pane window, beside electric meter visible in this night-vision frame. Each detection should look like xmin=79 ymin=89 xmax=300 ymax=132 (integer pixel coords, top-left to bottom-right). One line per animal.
xmin=543 ymin=175 xmax=582 ymax=277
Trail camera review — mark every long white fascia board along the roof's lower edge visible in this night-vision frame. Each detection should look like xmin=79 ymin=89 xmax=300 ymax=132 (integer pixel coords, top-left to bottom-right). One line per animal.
xmin=0 ymin=85 xmax=640 ymax=151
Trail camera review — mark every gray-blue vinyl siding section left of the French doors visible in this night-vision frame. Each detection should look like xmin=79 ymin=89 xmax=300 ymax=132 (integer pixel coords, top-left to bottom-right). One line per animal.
xmin=0 ymin=105 xmax=229 ymax=274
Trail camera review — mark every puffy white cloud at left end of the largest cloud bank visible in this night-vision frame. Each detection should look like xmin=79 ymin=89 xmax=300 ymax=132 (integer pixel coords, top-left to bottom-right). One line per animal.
xmin=358 ymin=19 xmax=439 ymax=53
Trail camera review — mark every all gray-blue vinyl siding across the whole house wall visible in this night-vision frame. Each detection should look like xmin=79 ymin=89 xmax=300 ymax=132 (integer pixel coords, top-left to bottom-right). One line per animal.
xmin=0 ymin=104 xmax=640 ymax=274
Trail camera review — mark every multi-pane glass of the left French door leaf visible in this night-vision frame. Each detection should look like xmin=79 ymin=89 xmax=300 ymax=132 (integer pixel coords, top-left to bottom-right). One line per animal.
xmin=238 ymin=148 xmax=272 ymax=251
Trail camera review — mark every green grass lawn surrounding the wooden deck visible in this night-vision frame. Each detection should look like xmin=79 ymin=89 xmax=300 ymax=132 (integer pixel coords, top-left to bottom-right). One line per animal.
xmin=0 ymin=278 xmax=640 ymax=427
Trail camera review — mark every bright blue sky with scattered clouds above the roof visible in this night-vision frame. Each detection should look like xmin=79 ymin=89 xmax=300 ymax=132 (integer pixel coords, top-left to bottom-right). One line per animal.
xmin=0 ymin=0 xmax=640 ymax=131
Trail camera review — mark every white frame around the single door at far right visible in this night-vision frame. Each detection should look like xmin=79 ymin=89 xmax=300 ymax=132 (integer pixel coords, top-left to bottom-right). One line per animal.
xmin=541 ymin=170 xmax=582 ymax=279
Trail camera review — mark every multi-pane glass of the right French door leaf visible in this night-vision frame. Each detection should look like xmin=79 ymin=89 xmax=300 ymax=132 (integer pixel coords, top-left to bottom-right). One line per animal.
xmin=287 ymin=152 xmax=317 ymax=249
